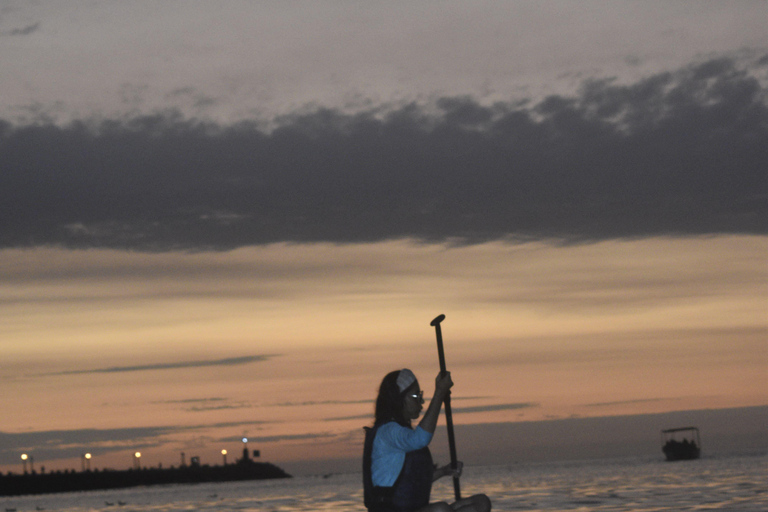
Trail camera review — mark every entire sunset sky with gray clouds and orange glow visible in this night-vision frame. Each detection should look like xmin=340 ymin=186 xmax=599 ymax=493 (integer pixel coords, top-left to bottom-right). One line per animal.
xmin=0 ymin=0 xmax=768 ymax=473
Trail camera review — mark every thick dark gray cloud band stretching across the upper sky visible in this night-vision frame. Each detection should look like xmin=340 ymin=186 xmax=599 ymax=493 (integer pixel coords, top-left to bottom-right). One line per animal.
xmin=0 ymin=53 xmax=768 ymax=251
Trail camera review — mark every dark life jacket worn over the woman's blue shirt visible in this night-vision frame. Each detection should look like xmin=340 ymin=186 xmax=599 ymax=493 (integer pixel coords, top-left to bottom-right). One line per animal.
xmin=363 ymin=425 xmax=434 ymax=512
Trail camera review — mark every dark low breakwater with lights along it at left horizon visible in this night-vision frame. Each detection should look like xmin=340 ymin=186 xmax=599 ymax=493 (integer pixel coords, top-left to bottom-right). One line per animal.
xmin=0 ymin=448 xmax=291 ymax=496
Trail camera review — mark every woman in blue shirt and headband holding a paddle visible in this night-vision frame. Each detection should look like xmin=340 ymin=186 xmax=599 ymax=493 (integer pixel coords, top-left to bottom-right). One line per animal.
xmin=363 ymin=368 xmax=491 ymax=512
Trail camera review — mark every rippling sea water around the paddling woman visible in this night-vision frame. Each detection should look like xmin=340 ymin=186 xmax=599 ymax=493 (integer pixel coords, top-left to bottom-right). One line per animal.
xmin=0 ymin=455 xmax=768 ymax=512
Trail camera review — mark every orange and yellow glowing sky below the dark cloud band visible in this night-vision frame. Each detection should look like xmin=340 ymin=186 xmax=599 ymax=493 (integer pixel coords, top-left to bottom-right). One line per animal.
xmin=0 ymin=237 xmax=768 ymax=476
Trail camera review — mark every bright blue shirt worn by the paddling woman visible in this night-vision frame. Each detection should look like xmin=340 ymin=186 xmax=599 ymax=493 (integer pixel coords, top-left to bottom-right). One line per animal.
xmin=371 ymin=421 xmax=432 ymax=487
